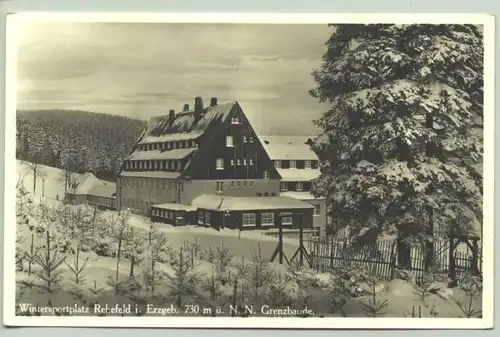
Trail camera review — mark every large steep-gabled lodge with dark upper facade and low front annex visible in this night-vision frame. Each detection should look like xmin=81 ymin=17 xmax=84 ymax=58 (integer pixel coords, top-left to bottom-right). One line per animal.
xmin=117 ymin=97 xmax=314 ymax=229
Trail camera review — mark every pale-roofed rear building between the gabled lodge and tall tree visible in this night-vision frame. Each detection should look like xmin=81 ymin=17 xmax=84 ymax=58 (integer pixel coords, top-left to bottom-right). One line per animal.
xmin=259 ymin=136 xmax=327 ymax=230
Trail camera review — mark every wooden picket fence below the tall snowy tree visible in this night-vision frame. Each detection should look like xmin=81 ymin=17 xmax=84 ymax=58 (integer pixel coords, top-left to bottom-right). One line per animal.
xmin=305 ymin=239 xmax=482 ymax=280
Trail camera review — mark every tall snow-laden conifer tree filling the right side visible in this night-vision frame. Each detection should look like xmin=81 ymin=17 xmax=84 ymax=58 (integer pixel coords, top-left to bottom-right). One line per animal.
xmin=310 ymin=24 xmax=484 ymax=262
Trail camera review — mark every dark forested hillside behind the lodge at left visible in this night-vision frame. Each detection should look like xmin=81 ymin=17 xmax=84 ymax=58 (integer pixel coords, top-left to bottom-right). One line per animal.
xmin=16 ymin=110 xmax=145 ymax=180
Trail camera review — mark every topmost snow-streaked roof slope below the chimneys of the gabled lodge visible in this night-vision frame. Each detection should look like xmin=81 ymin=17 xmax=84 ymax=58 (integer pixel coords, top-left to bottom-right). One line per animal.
xmin=138 ymin=102 xmax=237 ymax=144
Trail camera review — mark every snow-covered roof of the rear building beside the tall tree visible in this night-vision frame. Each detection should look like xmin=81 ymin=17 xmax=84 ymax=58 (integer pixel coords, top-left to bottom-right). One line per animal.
xmin=259 ymin=136 xmax=318 ymax=160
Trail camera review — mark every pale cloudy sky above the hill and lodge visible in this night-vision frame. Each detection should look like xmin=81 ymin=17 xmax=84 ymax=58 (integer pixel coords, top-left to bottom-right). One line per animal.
xmin=17 ymin=22 xmax=331 ymax=135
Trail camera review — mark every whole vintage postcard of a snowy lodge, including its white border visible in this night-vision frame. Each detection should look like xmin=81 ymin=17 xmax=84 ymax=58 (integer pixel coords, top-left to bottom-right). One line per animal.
xmin=4 ymin=14 xmax=494 ymax=329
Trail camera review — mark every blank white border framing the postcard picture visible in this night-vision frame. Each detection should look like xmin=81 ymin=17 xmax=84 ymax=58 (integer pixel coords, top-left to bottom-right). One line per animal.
xmin=4 ymin=12 xmax=495 ymax=329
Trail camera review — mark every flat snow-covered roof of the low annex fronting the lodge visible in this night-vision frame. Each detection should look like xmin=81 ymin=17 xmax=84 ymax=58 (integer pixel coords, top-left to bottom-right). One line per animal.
xmin=192 ymin=194 xmax=314 ymax=211
